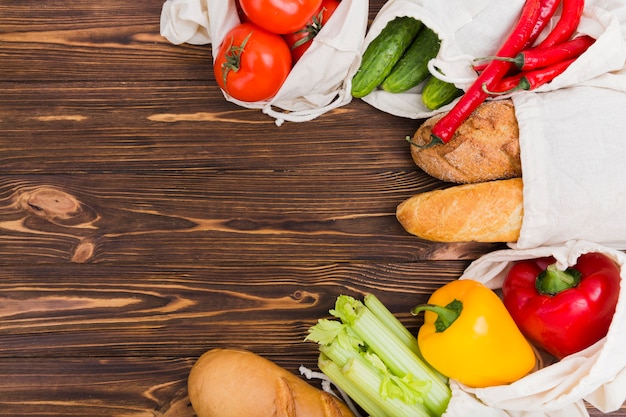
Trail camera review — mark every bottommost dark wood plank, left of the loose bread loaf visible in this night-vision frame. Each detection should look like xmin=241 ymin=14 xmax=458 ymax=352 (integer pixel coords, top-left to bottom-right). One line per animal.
xmin=0 ymin=356 xmax=195 ymax=417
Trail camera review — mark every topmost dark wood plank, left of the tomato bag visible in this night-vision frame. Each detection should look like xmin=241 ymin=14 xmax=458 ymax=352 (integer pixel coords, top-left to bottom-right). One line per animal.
xmin=0 ymin=0 xmax=211 ymax=83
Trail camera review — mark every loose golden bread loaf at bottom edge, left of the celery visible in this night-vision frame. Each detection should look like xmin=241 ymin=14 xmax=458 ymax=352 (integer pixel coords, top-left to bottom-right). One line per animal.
xmin=188 ymin=349 xmax=354 ymax=417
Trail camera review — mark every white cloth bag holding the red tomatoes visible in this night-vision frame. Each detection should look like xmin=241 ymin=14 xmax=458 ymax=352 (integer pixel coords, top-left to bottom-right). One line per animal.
xmin=161 ymin=0 xmax=369 ymax=125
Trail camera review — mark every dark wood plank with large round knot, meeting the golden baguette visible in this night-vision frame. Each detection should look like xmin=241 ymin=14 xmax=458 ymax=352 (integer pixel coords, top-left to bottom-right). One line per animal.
xmin=0 ymin=170 xmax=495 ymax=265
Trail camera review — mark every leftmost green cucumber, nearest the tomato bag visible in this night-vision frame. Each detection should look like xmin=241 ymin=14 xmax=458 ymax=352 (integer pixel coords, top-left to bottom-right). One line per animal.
xmin=351 ymin=16 xmax=423 ymax=98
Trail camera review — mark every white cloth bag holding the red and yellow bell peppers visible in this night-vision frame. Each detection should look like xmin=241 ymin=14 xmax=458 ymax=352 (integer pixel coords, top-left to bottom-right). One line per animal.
xmin=444 ymin=241 xmax=626 ymax=417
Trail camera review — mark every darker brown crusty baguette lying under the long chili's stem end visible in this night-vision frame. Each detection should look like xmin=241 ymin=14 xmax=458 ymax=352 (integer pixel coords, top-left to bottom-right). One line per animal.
xmin=411 ymin=100 xmax=522 ymax=183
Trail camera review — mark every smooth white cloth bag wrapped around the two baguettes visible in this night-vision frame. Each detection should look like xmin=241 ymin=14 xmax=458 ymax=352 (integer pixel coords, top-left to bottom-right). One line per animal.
xmin=513 ymin=87 xmax=626 ymax=249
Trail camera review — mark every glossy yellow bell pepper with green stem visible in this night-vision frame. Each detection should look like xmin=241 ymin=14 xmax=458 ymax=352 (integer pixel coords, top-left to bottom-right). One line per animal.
xmin=411 ymin=280 xmax=537 ymax=388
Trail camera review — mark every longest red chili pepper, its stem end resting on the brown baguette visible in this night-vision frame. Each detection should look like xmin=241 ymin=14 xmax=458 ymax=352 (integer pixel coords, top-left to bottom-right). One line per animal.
xmin=426 ymin=0 xmax=541 ymax=146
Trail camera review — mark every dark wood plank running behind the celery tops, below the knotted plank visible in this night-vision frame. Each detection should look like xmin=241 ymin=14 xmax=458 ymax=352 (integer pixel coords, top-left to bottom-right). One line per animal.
xmin=0 ymin=261 xmax=460 ymax=362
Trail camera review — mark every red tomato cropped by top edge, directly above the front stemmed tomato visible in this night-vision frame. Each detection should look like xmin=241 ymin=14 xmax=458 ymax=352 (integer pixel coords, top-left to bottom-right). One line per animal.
xmin=239 ymin=0 xmax=322 ymax=35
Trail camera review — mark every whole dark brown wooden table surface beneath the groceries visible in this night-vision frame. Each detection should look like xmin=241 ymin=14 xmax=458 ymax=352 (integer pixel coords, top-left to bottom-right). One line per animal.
xmin=0 ymin=0 xmax=626 ymax=417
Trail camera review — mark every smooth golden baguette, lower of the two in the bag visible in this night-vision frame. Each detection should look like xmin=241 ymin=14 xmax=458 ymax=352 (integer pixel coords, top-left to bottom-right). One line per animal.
xmin=396 ymin=178 xmax=524 ymax=242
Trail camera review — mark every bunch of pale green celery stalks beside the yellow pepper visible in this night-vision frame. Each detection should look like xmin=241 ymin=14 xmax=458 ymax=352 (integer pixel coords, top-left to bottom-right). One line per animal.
xmin=306 ymin=294 xmax=451 ymax=417
